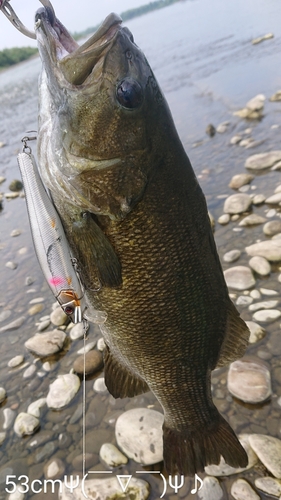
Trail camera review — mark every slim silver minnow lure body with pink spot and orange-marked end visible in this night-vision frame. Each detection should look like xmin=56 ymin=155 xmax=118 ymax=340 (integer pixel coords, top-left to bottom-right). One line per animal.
xmin=18 ymin=151 xmax=86 ymax=323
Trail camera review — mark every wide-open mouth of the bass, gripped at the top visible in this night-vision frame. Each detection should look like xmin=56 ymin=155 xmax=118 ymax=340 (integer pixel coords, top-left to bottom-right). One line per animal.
xmin=35 ymin=7 xmax=122 ymax=85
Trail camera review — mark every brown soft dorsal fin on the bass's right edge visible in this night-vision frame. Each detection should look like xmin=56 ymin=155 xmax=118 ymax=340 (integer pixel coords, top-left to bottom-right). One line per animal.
xmin=216 ymin=300 xmax=250 ymax=367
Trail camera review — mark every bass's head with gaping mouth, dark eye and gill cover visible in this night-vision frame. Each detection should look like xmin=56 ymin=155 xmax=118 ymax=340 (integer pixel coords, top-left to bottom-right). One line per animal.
xmin=36 ymin=8 xmax=170 ymax=219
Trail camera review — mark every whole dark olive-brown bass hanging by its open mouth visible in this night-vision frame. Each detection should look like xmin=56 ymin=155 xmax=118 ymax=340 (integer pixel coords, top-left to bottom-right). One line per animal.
xmin=36 ymin=8 xmax=249 ymax=475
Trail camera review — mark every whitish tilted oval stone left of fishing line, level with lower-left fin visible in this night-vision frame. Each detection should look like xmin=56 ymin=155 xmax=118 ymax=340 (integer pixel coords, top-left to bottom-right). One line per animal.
xmin=46 ymin=373 xmax=80 ymax=409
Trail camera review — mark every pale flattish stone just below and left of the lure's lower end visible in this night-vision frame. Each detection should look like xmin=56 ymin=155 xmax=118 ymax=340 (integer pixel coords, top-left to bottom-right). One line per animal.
xmin=24 ymin=330 xmax=66 ymax=358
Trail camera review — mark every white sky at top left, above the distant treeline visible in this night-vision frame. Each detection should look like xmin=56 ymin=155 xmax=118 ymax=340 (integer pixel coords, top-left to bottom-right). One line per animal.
xmin=0 ymin=0 xmax=145 ymax=50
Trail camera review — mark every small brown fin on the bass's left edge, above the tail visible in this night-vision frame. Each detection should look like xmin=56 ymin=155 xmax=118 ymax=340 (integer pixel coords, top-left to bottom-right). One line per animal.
xmin=103 ymin=346 xmax=150 ymax=398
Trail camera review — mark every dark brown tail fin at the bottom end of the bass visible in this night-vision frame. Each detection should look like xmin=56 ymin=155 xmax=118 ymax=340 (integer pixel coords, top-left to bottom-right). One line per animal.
xmin=163 ymin=413 xmax=248 ymax=476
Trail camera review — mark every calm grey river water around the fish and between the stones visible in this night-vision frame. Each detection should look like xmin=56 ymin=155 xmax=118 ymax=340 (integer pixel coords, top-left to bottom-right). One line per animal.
xmin=0 ymin=0 xmax=281 ymax=500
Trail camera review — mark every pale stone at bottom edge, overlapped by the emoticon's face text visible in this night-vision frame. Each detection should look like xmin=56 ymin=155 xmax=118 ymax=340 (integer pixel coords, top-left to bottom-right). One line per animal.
xmin=59 ymin=476 xmax=149 ymax=500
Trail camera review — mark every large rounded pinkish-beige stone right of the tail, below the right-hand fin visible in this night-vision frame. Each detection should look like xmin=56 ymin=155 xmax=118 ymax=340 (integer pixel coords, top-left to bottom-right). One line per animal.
xmin=227 ymin=358 xmax=272 ymax=403
